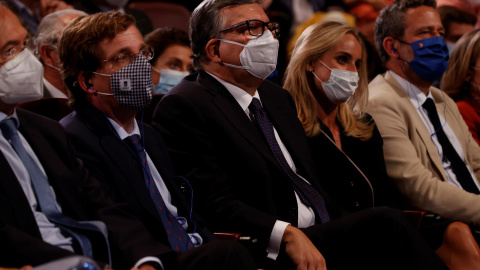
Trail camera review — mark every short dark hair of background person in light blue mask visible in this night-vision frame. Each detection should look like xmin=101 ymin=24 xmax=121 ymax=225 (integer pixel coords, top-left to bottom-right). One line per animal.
xmin=145 ymin=27 xmax=190 ymax=65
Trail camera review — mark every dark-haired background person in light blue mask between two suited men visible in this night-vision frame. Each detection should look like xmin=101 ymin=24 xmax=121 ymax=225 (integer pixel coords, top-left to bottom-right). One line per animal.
xmin=145 ymin=28 xmax=193 ymax=94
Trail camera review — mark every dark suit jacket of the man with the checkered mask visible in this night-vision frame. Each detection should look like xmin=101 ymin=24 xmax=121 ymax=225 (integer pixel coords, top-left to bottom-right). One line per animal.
xmin=60 ymin=105 xmax=213 ymax=265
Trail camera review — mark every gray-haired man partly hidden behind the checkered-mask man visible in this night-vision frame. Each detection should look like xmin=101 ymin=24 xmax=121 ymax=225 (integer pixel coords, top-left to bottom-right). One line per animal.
xmin=35 ymin=9 xmax=87 ymax=98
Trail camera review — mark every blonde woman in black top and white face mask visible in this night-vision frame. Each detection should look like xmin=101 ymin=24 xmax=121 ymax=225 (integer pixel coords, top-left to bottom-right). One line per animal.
xmin=284 ymin=22 xmax=400 ymax=211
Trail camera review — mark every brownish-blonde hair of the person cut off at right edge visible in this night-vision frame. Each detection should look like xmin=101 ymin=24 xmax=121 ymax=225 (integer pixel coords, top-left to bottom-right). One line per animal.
xmin=441 ymin=29 xmax=480 ymax=100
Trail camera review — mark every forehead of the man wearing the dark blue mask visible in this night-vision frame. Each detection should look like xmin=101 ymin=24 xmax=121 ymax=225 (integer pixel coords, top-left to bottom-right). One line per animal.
xmin=405 ymin=6 xmax=443 ymax=31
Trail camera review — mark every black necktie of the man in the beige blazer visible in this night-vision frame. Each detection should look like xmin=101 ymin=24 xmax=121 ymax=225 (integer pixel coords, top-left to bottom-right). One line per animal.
xmin=422 ymin=98 xmax=480 ymax=194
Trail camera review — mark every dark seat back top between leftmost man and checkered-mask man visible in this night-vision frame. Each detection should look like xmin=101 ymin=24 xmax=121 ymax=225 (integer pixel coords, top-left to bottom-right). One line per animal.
xmin=17 ymin=98 xmax=73 ymax=121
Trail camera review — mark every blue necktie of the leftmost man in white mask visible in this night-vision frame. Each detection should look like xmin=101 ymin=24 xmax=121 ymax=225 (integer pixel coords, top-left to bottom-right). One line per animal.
xmin=0 ymin=118 xmax=111 ymax=262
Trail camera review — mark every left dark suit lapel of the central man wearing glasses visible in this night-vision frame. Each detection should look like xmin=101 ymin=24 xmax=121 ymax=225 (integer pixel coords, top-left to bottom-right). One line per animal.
xmin=198 ymin=73 xmax=280 ymax=168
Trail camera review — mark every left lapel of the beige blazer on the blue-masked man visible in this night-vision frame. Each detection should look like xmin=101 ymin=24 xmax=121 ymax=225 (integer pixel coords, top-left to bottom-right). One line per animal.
xmin=385 ymin=72 xmax=447 ymax=181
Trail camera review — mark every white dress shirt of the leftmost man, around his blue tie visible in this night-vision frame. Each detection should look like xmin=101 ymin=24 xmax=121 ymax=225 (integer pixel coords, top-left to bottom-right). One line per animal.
xmin=0 ymin=111 xmax=73 ymax=252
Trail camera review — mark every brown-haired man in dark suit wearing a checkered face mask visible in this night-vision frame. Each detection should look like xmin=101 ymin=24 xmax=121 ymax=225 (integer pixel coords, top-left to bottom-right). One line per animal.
xmin=59 ymin=12 xmax=255 ymax=269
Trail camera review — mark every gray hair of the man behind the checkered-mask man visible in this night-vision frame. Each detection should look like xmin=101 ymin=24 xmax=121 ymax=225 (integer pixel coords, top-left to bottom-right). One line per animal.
xmin=35 ymin=9 xmax=88 ymax=53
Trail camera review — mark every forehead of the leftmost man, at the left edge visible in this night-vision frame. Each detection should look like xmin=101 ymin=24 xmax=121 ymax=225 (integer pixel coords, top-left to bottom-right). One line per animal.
xmin=0 ymin=6 xmax=27 ymax=49
